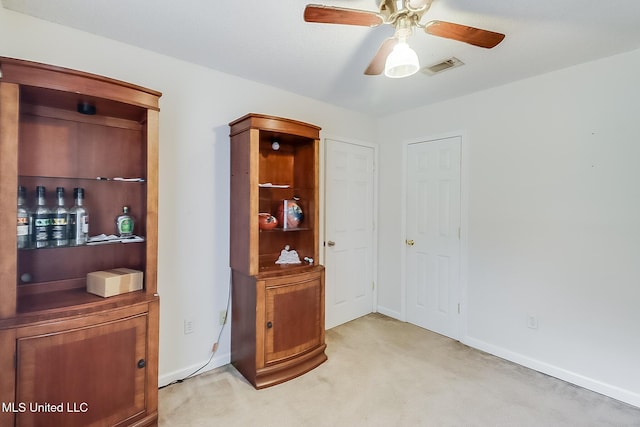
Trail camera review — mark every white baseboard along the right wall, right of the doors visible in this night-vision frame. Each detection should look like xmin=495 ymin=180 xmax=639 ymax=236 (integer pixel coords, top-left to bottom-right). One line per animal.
xmin=461 ymin=336 xmax=640 ymax=407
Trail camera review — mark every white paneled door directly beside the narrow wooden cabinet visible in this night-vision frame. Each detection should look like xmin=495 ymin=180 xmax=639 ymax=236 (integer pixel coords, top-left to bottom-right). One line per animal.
xmin=324 ymin=139 xmax=375 ymax=328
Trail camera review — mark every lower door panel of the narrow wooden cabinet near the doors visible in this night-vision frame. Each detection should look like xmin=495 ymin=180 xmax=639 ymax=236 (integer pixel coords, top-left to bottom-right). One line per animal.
xmin=265 ymin=275 xmax=324 ymax=364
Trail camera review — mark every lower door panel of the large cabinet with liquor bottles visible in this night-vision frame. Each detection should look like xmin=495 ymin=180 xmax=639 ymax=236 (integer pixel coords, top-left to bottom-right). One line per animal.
xmin=16 ymin=315 xmax=147 ymax=427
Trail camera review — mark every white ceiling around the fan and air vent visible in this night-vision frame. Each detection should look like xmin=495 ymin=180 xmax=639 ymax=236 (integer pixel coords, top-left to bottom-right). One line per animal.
xmin=2 ymin=0 xmax=640 ymax=116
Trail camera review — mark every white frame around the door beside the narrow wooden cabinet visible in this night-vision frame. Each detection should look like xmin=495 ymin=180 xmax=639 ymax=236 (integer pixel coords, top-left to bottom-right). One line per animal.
xmin=319 ymin=135 xmax=379 ymax=313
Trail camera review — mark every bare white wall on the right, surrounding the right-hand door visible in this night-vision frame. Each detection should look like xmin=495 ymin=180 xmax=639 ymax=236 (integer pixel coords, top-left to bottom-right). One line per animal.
xmin=378 ymin=51 xmax=640 ymax=406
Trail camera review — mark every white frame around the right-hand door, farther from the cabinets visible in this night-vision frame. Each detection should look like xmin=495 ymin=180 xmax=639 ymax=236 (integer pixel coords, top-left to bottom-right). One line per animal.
xmin=398 ymin=131 xmax=470 ymax=342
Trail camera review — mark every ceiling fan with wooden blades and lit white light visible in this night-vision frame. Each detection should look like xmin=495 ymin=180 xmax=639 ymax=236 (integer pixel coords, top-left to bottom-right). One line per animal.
xmin=304 ymin=0 xmax=505 ymax=78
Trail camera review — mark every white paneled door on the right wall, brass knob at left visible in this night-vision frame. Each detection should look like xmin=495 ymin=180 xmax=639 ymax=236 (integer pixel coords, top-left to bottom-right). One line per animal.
xmin=405 ymin=136 xmax=461 ymax=339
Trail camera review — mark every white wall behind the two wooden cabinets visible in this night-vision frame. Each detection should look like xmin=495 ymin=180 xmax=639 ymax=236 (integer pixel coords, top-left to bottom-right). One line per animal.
xmin=0 ymin=7 xmax=375 ymax=384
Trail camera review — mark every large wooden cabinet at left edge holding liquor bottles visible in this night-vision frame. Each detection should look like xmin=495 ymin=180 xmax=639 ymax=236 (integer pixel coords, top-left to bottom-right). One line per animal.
xmin=0 ymin=58 xmax=161 ymax=427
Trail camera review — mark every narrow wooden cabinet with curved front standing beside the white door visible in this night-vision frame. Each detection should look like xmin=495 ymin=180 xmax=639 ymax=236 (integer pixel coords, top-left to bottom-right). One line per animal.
xmin=229 ymin=114 xmax=327 ymax=388
